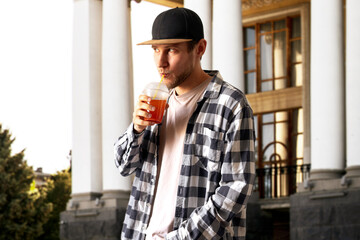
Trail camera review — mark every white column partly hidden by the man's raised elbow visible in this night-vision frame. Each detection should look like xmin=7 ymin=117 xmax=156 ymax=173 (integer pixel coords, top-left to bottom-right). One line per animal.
xmin=102 ymin=0 xmax=133 ymax=196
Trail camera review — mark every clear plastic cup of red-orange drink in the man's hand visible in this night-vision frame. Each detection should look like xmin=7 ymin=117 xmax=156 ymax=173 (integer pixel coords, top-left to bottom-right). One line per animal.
xmin=143 ymin=82 xmax=169 ymax=123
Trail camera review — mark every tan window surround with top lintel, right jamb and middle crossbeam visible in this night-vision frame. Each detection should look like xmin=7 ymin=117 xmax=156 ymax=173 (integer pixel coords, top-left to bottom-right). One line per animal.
xmin=242 ymin=0 xmax=311 ymax=164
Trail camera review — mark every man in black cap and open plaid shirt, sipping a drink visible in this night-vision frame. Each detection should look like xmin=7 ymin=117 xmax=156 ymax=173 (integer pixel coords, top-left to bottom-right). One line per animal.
xmin=115 ymin=8 xmax=255 ymax=239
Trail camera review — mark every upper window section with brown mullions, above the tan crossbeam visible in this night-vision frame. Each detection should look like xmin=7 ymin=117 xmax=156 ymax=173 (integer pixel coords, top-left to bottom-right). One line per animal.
xmin=244 ymin=16 xmax=303 ymax=94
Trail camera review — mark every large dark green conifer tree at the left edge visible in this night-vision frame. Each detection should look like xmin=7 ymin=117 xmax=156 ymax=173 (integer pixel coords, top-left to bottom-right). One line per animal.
xmin=0 ymin=124 xmax=52 ymax=240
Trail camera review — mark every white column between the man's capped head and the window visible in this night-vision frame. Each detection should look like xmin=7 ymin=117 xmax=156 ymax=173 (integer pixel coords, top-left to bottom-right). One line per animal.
xmin=213 ymin=0 xmax=245 ymax=91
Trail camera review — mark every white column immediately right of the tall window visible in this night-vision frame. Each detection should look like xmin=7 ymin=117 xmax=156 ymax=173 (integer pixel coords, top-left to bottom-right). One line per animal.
xmin=310 ymin=0 xmax=345 ymax=179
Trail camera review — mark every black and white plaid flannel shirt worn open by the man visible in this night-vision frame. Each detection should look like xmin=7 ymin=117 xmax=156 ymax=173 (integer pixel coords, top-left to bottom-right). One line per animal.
xmin=114 ymin=71 xmax=255 ymax=240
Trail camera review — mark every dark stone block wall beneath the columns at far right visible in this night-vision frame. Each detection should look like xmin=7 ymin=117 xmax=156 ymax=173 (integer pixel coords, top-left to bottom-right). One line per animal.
xmin=290 ymin=188 xmax=360 ymax=240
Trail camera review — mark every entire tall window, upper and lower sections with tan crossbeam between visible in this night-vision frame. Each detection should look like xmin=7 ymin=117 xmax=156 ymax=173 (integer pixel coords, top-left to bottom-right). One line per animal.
xmin=244 ymin=16 xmax=304 ymax=198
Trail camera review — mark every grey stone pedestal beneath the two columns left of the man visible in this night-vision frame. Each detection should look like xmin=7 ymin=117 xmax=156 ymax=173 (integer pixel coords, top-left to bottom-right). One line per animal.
xmin=60 ymin=190 xmax=130 ymax=240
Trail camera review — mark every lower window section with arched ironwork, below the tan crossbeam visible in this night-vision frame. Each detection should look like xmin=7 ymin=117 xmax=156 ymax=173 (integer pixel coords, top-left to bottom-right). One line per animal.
xmin=255 ymin=108 xmax=303 ymax=198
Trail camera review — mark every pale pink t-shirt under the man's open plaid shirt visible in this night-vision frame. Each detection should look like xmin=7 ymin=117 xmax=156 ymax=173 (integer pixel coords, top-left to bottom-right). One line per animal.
xmin=146 ymin=78 xmax=211 ymax=240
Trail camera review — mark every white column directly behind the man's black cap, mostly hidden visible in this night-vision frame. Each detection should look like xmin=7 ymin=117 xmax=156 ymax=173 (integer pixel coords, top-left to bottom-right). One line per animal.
xmin=184 ymin=0 xmax=212 ymax=70
